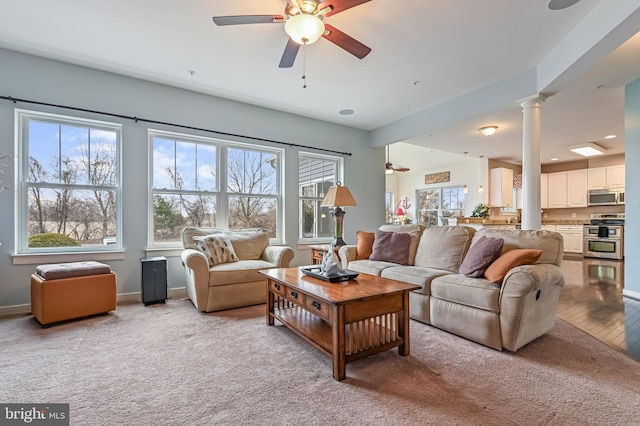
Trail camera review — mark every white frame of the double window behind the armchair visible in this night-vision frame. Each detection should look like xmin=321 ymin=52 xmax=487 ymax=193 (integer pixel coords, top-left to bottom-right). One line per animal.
xmin=147 ymin=129 xmax=284 ymax=250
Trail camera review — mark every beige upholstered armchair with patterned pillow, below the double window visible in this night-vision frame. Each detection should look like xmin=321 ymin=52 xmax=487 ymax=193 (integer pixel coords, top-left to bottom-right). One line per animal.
xmin=182 ymin=227 xmax=294 ymax=312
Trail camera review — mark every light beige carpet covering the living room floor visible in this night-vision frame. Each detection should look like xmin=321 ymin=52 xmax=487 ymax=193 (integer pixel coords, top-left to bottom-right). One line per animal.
xmin=0 ymin=299 xmax=640 ymax=426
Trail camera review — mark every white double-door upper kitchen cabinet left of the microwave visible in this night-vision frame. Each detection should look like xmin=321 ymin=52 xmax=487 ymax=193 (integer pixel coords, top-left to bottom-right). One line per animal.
xmin=548 ymin=169 xmax=587 ymax=209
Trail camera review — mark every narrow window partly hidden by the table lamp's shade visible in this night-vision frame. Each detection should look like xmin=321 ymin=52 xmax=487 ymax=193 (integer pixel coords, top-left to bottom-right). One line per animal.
xmin=298 ymin=152 xmax=342 ymax=242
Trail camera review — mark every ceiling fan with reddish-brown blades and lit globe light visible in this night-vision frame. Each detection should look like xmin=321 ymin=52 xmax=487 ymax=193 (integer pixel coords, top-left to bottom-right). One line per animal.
xmin=213 ymin=0 xmax=371 ymax=68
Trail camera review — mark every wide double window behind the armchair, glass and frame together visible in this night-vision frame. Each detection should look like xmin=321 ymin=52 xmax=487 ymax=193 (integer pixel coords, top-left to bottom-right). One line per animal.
xmin=149 ymin=130 xmax=282 ymax=247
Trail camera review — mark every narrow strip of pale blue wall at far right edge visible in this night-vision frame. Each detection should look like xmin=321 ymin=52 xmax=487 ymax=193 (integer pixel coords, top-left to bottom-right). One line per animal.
xmin=624 ymin=79 xmax=640 ymax=299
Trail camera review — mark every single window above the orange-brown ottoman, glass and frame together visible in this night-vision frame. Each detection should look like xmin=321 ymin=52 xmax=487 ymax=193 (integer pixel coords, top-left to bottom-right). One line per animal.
xmin=16 ymin=110 xmax=122 ymax=253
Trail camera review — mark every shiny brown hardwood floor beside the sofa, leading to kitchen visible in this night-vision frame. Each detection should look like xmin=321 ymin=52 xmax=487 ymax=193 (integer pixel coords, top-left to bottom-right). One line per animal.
xmin=558 ymin=257 xmax=640 ymax=361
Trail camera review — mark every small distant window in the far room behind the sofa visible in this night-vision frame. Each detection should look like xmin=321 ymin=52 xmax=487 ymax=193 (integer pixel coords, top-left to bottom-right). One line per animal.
xmin=417 ymin=186 xmax=465 ymax=226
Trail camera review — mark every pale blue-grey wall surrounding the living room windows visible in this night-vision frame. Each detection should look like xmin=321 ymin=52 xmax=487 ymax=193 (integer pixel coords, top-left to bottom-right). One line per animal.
xmin=0 ymin=49 xmax=384 ymax=307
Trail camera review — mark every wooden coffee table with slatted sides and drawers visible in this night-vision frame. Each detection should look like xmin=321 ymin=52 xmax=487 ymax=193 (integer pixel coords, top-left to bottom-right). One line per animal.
xmin=260 ymin=268 xmax=420 ymax=380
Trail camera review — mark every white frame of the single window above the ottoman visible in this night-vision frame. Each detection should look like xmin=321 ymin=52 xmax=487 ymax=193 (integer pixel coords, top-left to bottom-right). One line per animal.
xmin=14 ymin=109 xmax=123 ymax=256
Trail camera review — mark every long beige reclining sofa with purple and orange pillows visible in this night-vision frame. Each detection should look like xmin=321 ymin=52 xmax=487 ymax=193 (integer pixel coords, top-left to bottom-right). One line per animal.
xmin=339 ymin=225 xmax=564 ymax=351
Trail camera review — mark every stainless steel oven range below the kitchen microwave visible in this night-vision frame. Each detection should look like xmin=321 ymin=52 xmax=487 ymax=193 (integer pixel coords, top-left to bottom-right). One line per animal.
xmin=584 ymin=213 xmax=624 ymax=260
